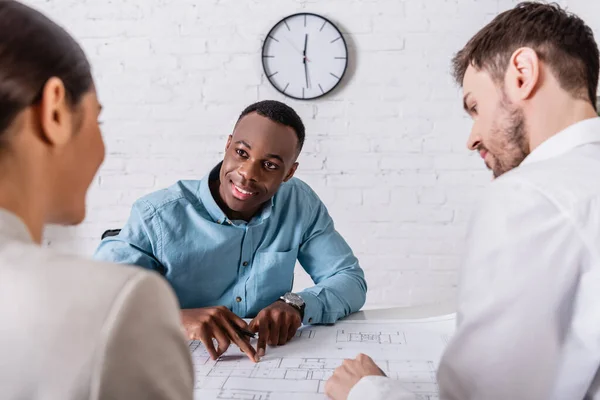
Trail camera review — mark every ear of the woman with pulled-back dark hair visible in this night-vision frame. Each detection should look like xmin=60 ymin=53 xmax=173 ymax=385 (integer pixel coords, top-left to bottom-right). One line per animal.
xmin=39 ymin=77 xmax=73 ymax=147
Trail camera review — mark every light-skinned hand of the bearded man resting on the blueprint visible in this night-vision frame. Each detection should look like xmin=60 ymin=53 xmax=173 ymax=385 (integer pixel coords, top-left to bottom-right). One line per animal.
xmin=325 ymin=354 xmax=385 ymax=400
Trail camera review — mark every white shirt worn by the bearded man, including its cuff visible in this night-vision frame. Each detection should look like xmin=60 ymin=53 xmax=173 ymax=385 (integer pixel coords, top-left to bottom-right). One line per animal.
xmin=349 ymin=118 xmax=600 ymax=400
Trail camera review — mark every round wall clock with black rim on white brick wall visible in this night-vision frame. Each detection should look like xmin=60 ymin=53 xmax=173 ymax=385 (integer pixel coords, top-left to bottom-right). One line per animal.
xmin=262 ymin=13 xmax=348 ymax=100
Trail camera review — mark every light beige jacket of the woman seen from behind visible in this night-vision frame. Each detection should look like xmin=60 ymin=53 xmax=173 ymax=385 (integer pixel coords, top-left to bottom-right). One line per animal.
xmin=0 ymin=209 xmax=193 ymax=400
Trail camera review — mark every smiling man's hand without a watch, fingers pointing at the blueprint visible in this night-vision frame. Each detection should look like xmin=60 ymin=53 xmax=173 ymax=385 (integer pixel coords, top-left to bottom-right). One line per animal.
xmin=181 ymin=306 xmax=258 ymax=362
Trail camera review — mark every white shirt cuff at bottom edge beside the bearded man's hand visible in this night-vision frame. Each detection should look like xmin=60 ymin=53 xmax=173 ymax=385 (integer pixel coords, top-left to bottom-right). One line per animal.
xmin=348 ymin=375 xmax=417 ymax=400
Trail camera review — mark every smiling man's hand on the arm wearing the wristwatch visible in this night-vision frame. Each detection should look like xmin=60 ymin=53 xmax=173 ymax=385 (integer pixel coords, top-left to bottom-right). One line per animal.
xmin=250 ymin=301 xmax=302 ymax=357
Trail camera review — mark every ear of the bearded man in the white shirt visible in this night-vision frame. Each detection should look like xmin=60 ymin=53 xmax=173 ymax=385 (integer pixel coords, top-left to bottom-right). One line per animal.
xmin=504 ymin=47 xmax=540 ymax=102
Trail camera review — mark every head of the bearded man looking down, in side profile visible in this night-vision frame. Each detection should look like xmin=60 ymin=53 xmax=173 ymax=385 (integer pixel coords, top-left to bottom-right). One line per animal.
xmin=453 ymin=2 xmax=600 ymax=177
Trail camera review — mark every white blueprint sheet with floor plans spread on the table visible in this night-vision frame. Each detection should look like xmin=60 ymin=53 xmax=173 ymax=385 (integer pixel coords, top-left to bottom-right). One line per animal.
xmin=189 ymin=314 xmax=455 ymax=400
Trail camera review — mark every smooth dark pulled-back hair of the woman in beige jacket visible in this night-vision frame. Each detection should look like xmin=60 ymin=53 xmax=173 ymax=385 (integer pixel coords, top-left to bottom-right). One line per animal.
xmin=0 ymin=0 xmax=93 ymax=140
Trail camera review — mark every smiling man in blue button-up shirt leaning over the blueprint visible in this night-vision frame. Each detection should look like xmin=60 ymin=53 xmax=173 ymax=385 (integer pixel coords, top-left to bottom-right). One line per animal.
xmin=95 ymin=101 xmax=367 ymax=360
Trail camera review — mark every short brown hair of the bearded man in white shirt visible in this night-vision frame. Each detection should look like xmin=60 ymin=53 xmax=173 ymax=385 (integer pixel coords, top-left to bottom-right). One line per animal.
xmin=452 ymin=2 xmax=600 ymax=108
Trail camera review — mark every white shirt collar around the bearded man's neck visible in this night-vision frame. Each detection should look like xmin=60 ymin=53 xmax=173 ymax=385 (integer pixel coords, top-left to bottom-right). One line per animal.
xmin=521 ymin=117 xmax=600 ymax=165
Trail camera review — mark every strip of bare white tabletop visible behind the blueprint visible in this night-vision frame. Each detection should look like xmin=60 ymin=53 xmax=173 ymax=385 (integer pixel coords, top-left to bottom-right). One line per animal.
xmin=343 ymin=303 xmax=456 ymax=321
